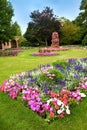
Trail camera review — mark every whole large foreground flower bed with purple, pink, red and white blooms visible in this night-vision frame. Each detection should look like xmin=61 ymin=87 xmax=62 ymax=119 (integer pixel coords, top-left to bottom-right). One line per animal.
xmin=0 ymin=58 xmax=87 ymax=122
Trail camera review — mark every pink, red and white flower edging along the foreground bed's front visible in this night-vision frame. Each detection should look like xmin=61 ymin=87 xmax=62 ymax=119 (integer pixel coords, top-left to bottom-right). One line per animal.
xmin=0 ymin=77 xmax=87 ymax=122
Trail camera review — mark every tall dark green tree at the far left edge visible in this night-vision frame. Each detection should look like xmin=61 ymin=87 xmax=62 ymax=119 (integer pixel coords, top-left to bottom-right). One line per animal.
xmin=0 ymin=0 xmax=14 ymax=43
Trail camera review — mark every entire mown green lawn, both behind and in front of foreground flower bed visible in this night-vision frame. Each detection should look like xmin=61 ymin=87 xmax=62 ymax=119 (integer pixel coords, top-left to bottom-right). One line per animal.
xmin=0 ymin=48 xmax=87 ymax=130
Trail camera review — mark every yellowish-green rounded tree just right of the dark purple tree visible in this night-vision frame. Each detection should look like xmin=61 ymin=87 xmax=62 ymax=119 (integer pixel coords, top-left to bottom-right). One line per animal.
xmin=60 ymin=18 xmax=81 ymax=45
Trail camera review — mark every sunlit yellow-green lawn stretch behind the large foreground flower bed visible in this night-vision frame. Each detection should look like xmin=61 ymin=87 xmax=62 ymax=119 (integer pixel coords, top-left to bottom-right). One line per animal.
xmin=0 ymin=48 xmax=87 ymax=84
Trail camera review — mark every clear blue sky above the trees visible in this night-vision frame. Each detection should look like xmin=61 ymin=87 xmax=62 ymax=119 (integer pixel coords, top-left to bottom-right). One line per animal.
xmin=9 ymin=0 xmax=81 ymax=34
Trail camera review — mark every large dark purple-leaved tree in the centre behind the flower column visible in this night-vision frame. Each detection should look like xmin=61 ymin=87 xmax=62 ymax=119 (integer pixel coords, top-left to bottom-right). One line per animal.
xmin=24 ymin=7 xmax=61 ymax=46
